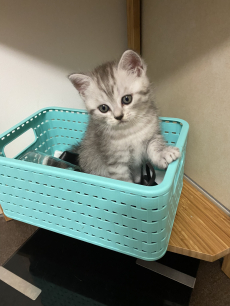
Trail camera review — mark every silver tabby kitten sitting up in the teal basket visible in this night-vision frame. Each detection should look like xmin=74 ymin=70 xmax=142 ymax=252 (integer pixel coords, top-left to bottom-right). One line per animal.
xmin=69 ymin=50 xmax=180 ymax=183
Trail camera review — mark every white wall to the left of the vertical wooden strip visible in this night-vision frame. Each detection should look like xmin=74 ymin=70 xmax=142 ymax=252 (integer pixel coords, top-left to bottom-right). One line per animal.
xmin=0 ymin=0 xmax=127 ymax=133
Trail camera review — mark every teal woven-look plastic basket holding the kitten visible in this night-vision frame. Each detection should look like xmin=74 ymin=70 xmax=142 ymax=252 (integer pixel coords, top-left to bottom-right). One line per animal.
xmin=0 ymin=107 xmax=188 ymax=260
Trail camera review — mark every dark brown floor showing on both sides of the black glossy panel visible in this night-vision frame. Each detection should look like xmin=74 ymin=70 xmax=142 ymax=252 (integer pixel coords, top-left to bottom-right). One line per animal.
xmin=0 ymin=215 xmax=230 ymax=306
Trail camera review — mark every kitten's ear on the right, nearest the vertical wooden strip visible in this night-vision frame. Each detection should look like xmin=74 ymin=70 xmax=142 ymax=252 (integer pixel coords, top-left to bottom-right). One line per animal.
xmin=118 ymin=50 xmax=146 ymax=76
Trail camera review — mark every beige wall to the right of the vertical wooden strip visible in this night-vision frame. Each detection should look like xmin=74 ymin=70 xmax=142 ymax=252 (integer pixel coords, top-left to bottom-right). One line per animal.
xmin=142 ymin=0 xmax=230 ymax=209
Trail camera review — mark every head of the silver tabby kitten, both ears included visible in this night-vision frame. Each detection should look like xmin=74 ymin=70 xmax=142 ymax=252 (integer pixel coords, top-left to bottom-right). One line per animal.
xmin=69 ymin=50 xmax=150 ymax=128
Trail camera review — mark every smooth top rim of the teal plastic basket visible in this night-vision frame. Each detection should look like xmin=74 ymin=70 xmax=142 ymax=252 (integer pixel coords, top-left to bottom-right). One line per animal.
xmin=0 ymin=106 xmax=189 ymax=197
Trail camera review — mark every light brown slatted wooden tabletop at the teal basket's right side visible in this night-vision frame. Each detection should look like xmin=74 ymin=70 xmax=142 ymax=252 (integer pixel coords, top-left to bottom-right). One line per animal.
xmin=168 ymin=179 xmax=230 ymax=277
